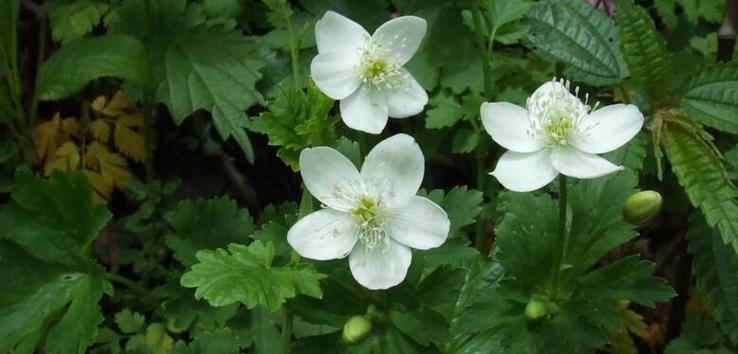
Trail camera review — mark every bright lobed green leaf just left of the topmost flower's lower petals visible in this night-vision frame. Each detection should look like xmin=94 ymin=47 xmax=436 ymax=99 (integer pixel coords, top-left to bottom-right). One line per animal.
xmin=251 ymin=82 xmax=336 ymax=171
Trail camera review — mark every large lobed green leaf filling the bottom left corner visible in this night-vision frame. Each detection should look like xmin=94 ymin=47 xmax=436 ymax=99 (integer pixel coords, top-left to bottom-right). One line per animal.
xmin=0 ymin=170 xmax=111 ymax=353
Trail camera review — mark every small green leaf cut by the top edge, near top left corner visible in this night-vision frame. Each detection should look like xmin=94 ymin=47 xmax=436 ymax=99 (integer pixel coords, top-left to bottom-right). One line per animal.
xmin=48 ymin=0 xmax=110 ymax=44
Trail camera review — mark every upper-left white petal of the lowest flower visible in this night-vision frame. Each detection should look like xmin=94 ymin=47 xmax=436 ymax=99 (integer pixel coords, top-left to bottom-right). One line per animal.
xmin=300 ymin=146 xmax=361 ymax=210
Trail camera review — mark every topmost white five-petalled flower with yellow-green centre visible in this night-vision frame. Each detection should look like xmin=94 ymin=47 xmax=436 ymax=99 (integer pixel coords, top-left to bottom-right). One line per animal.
xmin=310 ymin=11 xmax=428 ymax=134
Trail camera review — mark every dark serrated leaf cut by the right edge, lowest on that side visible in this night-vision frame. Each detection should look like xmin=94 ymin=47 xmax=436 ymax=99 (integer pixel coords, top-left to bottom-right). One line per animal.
xmin=687 ymin=218 xmax=738 ymax=344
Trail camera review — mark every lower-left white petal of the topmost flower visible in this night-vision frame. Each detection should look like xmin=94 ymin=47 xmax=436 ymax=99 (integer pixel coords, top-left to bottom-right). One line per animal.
xmin=310 ymin=52 xmax=361 ymax=100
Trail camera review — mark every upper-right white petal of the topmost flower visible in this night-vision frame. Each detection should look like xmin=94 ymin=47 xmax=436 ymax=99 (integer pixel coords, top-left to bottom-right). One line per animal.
xmin=372 ymin=16 xmax=428 ymax=65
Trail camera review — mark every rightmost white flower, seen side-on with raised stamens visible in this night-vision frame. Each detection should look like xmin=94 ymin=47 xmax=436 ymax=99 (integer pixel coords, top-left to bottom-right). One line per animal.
xmin=481 ymin=80 xmax=643 ymax=192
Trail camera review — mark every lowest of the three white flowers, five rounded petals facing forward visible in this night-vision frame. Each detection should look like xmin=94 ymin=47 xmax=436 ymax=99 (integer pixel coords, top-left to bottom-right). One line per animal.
xmin=287 ymin=134 xmax=449 ymax=289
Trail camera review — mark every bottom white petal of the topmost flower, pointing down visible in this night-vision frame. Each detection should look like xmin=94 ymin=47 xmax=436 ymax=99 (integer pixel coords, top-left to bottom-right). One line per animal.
xmin=340 ymin=85 xmax=388 ymax=134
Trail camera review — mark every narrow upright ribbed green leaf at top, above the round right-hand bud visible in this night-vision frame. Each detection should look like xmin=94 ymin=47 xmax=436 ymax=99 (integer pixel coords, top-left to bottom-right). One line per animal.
xmin=615 ymin=0 xmax=671 ymax=105
